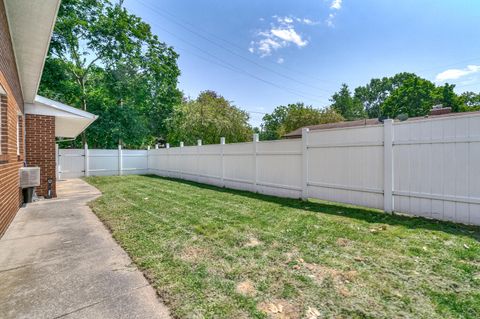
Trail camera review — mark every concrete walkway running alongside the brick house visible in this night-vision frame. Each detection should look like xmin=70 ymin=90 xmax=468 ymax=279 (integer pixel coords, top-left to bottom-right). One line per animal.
xmin=0 ymin=180 xmax=169 ymax=318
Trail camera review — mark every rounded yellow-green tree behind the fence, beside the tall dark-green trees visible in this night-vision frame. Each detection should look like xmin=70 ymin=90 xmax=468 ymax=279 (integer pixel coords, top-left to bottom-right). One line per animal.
xmin=168 ymin=91 xmax=253 ymax=145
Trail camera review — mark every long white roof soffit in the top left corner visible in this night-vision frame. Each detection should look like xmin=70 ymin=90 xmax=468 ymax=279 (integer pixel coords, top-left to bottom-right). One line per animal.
xmin=4 ymin=0 xmax=60 ymax=103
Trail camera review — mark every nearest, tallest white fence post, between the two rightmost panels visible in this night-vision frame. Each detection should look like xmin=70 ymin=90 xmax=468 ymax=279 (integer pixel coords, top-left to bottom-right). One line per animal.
xmin=383 ymin=119 xmax=394 ymax=213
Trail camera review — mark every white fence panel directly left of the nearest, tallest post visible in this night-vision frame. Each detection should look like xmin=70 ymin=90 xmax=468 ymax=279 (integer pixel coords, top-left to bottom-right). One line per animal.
xmin=307 ymin=126 xmax=383 ymax=209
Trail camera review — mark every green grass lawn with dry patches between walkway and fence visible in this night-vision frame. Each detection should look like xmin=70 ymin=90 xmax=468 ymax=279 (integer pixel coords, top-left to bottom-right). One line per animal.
xmin=87 ymin=176 xmax=480 ymax=319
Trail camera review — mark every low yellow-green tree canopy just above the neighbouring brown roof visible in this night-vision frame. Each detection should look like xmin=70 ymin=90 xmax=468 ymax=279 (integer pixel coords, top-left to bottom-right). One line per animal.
xmin=260 ymin=103 xmax=344 ymax=140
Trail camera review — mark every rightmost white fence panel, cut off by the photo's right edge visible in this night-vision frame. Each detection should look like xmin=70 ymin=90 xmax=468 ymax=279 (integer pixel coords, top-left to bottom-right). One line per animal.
xmin=393 ymin=115 xmax=480 ymax=224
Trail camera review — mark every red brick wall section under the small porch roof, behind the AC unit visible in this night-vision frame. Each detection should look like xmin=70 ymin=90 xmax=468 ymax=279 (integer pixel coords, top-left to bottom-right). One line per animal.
xmin=25 ymin=114 xmax=57 ymax=197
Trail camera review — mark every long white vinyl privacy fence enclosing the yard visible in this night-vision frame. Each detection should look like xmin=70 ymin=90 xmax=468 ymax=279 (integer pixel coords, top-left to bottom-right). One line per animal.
xmin=59 ymin=114 xmax=480 ymax=225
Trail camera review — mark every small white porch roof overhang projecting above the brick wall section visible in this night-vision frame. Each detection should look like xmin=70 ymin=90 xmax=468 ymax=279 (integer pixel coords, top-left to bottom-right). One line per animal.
xmin=25 ymin=95 xmax=98 ymax=138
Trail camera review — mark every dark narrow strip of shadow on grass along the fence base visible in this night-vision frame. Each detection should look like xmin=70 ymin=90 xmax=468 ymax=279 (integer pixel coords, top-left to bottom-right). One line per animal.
xmin=142 ymin=175 xmax=480 ymax=241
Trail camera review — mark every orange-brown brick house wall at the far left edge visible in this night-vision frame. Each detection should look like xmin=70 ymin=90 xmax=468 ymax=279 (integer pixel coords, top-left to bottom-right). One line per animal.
xmin=0 ymin=0 xmax=25 ymax=237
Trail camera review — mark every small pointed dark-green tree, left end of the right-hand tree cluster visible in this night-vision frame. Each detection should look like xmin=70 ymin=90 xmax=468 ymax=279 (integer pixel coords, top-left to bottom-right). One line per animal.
xmin=330 ymin=83 xmax=365 ymax=121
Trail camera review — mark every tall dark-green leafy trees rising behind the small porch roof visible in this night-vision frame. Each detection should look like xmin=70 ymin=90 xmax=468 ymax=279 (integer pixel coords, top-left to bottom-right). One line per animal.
xmin=40 ymin=0 xmax=181 ymax=147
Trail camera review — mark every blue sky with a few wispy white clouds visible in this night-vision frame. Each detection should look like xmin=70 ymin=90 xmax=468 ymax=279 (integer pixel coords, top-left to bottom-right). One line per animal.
xmin=124 ymin=0 xmax=480 ymax=126
